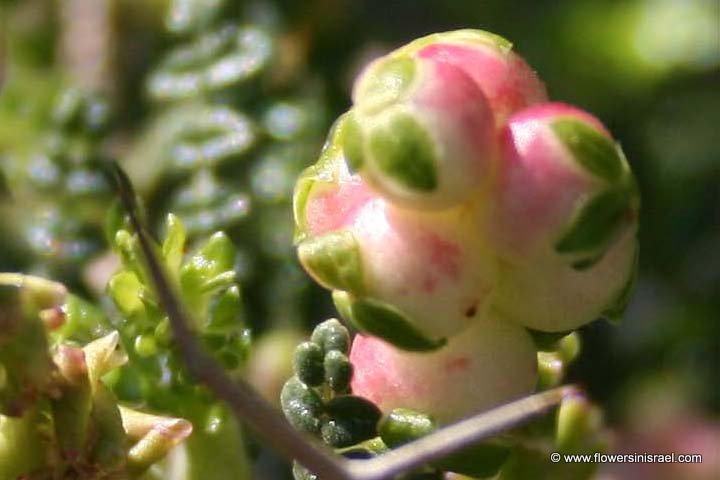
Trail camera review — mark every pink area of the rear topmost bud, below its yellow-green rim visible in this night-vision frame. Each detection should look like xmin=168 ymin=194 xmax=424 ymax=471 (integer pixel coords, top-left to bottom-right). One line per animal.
xmin=418 ymin=43 xmax=547 ymax=125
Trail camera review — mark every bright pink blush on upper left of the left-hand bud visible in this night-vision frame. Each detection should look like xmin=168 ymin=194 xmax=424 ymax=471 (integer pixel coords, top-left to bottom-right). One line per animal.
xmin=305 ymin=178 xmax=377 ymax=235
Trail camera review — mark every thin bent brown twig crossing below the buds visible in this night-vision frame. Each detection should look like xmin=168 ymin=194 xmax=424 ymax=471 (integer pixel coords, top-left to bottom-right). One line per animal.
xmin=111 ymin=163 xmax=579 ymax=480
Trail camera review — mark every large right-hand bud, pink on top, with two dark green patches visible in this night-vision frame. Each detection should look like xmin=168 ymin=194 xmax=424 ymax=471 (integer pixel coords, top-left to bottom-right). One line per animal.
xmin=482 ymin=103 xmax=639 ymax=331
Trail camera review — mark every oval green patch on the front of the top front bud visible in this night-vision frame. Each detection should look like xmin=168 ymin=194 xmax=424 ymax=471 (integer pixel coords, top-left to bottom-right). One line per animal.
xmin=370 ymin=114 xmax=438 ymax=192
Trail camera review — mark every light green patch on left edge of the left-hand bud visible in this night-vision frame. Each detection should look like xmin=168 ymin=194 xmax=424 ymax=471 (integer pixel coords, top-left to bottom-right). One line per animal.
xmin=298 ymin=230 xmax=364 ymax=293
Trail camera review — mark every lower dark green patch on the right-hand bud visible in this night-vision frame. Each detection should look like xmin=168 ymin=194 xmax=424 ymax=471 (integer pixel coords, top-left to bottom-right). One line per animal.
xmin=555 ymin=188 xmax=630 ymax=258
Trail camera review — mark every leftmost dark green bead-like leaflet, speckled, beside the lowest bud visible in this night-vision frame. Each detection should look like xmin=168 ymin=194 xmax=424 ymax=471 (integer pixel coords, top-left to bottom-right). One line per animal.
xmin=280 ymin=377 xmax=323 ymax=434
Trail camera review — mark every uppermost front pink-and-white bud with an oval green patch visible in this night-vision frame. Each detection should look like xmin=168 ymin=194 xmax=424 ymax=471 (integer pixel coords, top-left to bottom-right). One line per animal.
xmin=342 ymin=55 xmax=496 ymax=209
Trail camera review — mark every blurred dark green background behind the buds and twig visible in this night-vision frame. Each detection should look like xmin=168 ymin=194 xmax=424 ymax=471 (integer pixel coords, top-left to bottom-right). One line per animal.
xmin=0 ymin=0 xmax=720 ymax=479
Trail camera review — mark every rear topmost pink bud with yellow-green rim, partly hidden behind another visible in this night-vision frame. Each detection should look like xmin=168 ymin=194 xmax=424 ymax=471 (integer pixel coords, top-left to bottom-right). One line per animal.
xmin=391 ymin=29 xmax=547 ymax=127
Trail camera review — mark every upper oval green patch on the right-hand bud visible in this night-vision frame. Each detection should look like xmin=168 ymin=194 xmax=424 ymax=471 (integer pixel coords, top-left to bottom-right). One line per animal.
xmin=551 ymin=119 xmax=623 ymax=182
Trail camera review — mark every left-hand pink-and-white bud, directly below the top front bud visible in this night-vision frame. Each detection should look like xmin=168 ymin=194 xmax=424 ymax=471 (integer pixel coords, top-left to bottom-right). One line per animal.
xmin=296 ymin=143 xmax=493 ymax=341
